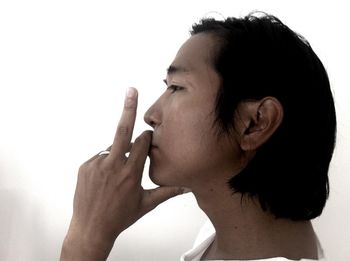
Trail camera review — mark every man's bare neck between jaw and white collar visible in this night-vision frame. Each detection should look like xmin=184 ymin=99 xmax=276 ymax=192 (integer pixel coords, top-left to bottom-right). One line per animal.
xmin=193 ymin=184 xmax=317 ymax=260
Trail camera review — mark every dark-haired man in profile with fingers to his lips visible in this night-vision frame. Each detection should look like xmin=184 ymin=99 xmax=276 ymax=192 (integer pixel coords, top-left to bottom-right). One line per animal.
xmin=61 ymin=12 xmax=336 ymax=260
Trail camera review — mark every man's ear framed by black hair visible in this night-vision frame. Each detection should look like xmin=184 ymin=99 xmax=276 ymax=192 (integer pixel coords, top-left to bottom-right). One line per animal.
xmin=235 ymin=97 xmax=283 ymax=151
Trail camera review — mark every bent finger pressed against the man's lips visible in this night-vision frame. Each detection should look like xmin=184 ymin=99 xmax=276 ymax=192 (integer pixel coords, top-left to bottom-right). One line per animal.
xmin=126 ymin=131 xmax=152 ymax=179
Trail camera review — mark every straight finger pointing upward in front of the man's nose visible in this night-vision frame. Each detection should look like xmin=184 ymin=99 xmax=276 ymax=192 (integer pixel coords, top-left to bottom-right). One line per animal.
xmin=110 ymin=88 xmax=137 ymax=159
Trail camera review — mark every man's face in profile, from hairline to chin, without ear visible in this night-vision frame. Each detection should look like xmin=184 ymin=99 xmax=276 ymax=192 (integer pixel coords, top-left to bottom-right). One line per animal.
xmin=145 ymin=34 xmax=239 ymax=189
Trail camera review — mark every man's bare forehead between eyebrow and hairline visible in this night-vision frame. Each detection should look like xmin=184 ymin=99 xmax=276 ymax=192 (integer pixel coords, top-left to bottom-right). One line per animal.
xmin=172 ymin=33 xmax=215 ymax=71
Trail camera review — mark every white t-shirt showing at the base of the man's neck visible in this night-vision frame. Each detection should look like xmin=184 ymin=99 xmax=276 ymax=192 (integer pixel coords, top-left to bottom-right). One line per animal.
xmin=180 ymin=220 xmax=325 ymax=261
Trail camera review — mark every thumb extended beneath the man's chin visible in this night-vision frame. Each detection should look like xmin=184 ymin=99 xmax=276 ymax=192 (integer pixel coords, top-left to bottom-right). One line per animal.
xmin=143 ymin=187 xmax=188 ymax=212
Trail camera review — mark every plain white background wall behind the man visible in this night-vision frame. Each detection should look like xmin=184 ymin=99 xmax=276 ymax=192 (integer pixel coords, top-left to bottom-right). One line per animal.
xmin=0 ymin=0 xmax=350 ymax=261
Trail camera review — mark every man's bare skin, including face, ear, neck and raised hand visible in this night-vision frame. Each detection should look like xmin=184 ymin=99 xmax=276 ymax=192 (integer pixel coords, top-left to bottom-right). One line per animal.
xmin=61 ymin=34 xmax=317 ymax=260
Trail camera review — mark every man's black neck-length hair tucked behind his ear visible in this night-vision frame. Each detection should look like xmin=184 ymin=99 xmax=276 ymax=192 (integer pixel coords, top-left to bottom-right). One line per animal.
xmin=191 ymin=12 xmax=336 ymax=220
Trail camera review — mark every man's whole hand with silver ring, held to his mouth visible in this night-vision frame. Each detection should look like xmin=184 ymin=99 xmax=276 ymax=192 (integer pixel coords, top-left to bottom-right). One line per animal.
xmin=61 ymin=88 xmax=183 ymax=260
